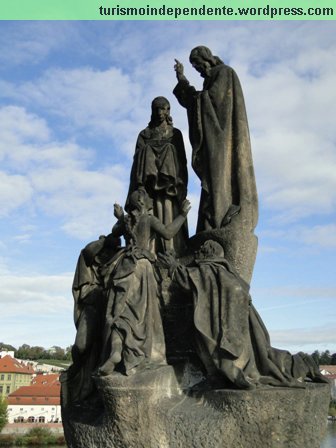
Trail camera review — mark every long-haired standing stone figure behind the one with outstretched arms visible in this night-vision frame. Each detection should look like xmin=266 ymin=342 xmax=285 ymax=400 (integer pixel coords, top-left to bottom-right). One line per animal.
xmin=126 ymin=96 xmax=188 ymax=253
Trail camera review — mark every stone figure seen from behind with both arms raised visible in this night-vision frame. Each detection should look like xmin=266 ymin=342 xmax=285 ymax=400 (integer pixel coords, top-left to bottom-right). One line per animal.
xmin=98 ymin=188 xmax=190 ymax=375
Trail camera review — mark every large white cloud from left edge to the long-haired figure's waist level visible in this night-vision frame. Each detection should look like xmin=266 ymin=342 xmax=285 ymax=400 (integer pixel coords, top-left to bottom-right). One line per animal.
xmin=0 ymin=106 xmax=129 ymax=238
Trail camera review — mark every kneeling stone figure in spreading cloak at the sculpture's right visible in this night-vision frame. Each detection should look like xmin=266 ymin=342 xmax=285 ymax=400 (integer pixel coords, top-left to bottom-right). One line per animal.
xmin=159 ymin=240 xmax=325 ymax=389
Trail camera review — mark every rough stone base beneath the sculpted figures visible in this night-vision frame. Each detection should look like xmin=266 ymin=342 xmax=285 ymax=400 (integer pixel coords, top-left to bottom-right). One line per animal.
xmin=62 ymin=366 xmax=330 ymax=448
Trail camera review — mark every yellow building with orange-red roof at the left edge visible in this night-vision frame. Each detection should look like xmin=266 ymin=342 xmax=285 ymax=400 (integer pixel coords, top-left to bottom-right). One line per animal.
xmin=0 ymin=355 xmax=34 ymax=397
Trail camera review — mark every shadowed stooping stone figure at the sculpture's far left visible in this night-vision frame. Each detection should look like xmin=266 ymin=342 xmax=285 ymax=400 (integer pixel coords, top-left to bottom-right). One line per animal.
xmin=61 ymin=235 xmax=120 ymax=404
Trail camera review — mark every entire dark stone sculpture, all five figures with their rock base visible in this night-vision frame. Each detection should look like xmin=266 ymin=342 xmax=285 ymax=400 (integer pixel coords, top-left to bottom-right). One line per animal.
xmin=61 ymin=46 xmax=330 ymax=448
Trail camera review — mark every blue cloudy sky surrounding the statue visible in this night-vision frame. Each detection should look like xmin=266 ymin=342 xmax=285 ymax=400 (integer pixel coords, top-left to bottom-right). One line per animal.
xmin=0 ymin=21 xmax=336 ymax=352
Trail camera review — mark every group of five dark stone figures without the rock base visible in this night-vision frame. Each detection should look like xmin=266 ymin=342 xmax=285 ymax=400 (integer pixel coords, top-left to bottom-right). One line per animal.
xmin=62 ymin=46 xmax=325 ymax=446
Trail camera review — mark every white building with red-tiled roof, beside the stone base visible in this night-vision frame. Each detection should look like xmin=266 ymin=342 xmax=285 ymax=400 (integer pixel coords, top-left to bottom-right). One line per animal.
xmin=7 ymin=374 xmax=61 ymax=423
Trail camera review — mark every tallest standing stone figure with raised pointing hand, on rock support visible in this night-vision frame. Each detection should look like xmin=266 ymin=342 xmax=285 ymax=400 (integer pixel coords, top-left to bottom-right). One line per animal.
xmin=174 ymin=46 xmax=258 ymax=282
